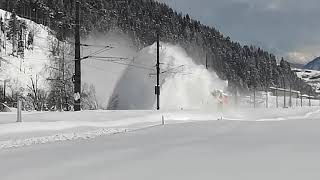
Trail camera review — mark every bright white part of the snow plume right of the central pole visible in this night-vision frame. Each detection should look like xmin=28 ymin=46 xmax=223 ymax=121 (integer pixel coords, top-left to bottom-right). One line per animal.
xmin=159 ymin=44 xmax=226 ymax=109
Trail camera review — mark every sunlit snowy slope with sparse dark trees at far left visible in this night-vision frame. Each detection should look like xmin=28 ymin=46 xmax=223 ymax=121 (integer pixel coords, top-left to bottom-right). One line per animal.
xmin=0 ymin=9 xmax=54 ymax=93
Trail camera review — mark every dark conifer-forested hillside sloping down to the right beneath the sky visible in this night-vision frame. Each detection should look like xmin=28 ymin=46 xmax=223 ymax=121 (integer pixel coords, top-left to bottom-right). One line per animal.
xmin=1 ymin=0 xmax=311 ymax=93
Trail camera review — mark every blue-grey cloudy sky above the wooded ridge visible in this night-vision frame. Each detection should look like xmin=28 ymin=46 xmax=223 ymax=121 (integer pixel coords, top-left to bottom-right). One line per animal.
xmin=159 ymin=0 xmax=320 ymax=63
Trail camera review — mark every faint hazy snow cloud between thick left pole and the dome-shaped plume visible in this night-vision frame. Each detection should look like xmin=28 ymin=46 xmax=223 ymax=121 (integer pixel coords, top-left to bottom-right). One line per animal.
xmin=81 ymin=32 xmax=137 ymax=108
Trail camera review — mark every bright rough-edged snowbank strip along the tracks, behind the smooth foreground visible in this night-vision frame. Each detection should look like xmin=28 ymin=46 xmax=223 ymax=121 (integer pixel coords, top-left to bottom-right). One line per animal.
xmin=0 ymin=107 xmax=319 ymax=149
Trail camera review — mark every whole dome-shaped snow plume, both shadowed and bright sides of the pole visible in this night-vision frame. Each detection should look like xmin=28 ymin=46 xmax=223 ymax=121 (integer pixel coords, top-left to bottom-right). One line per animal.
xmin=109 ymin=43 xmax=226 ymax=109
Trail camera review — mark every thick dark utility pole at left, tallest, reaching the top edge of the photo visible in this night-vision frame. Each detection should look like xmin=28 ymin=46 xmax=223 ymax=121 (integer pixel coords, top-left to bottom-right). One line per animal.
xmin=74 ymin=1 xmax=81 ymax=111
